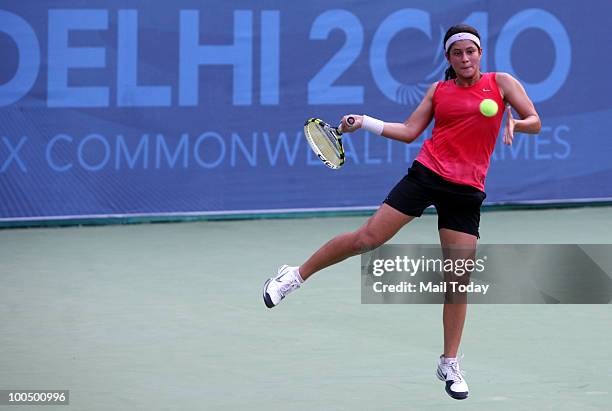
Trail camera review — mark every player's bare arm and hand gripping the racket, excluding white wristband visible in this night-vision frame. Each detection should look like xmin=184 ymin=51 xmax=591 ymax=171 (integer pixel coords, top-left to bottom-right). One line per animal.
xmin=342 ymin=82 xmax=438 ymax=143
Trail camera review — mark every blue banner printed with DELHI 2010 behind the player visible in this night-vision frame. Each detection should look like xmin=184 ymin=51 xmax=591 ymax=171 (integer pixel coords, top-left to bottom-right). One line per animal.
xmin=0 ymin=0 xmax=612 ymax=221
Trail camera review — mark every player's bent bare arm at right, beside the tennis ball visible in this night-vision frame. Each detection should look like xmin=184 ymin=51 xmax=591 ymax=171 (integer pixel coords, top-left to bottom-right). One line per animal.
xmin=495 ymin=73 xmax=542 ymax=144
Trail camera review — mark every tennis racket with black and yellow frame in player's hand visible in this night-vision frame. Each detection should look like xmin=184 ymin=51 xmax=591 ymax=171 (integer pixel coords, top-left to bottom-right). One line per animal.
xmin=304 ymin=117 xmax=355 ymax=169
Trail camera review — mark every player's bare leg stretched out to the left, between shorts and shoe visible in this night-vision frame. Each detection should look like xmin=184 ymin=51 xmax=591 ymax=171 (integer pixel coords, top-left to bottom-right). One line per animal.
xmin=299 ymin=203 xmax=414 ymax=280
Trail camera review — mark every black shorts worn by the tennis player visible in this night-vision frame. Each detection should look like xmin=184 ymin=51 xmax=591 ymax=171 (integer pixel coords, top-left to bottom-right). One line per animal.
xmin=384 ymin=161 xmax=487 ymax=238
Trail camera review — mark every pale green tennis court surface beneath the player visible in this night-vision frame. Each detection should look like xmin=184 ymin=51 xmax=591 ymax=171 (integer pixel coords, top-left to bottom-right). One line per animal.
xmin=0 ymin=207 xmax=612 ymax=410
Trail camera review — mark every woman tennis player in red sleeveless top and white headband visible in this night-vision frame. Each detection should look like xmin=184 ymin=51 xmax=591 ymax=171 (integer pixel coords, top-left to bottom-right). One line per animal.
xmin=263 ymin=24 xmax=541 ymax=399
